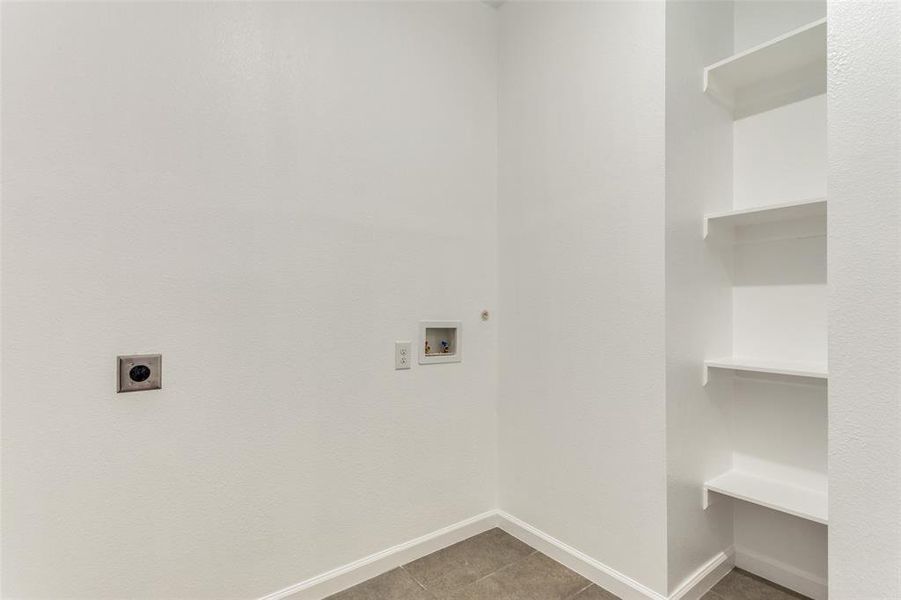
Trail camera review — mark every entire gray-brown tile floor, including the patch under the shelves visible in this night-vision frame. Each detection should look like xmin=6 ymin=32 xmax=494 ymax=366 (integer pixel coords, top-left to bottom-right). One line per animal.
xmin=327 ymin=529 xmax=804 ymax=600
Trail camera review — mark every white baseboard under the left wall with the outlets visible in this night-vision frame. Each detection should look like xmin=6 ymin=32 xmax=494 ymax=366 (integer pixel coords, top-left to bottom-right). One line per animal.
xmin=259 ymin=510 xmax=497 ymax=600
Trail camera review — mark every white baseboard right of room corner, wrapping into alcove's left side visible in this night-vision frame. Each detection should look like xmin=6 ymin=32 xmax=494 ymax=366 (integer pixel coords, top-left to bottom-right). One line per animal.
xmin=498 ymin=511 xmax=733 ymax=600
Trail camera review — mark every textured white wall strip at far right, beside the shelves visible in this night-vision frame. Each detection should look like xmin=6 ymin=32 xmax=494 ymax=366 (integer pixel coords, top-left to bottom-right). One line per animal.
xmin=828 ymin=2 xmax=901 ymax=600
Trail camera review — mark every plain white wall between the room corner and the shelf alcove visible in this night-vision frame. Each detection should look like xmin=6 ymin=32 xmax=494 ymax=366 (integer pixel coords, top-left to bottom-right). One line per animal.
xmin=499 ymin=2 xmax=667 ymax=593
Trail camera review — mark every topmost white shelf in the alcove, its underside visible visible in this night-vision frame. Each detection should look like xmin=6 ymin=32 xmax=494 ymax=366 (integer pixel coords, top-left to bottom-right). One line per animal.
xmin=704 ymin=19 xmax=826 ymax=119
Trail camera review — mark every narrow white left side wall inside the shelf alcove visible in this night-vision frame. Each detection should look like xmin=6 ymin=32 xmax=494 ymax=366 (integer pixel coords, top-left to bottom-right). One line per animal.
xmin=666 ymin=0 xmax=733 ymax=590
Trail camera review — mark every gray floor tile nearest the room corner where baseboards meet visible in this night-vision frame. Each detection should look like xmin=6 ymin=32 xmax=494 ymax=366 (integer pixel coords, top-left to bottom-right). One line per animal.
xmin=404 ymin=529 xmax=534 ymax=597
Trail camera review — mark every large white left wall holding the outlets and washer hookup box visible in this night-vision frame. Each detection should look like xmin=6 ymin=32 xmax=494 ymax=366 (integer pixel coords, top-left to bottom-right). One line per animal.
xmin=2 ymin=3 xmax=500 ymax=599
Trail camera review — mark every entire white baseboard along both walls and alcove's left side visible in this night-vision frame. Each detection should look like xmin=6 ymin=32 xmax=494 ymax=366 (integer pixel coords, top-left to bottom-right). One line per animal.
xmin=259 ymin=510 xmax=736 ymax=600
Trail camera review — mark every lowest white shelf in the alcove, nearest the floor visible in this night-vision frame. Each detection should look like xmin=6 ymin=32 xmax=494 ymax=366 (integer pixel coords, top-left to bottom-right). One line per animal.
xmin=703 ymin=471 xmax=828 ymax=525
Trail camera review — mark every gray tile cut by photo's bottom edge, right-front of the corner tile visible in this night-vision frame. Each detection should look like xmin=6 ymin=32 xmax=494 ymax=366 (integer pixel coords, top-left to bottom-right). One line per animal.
xmin=436 ymin=552 xmax=591 ymax=600
